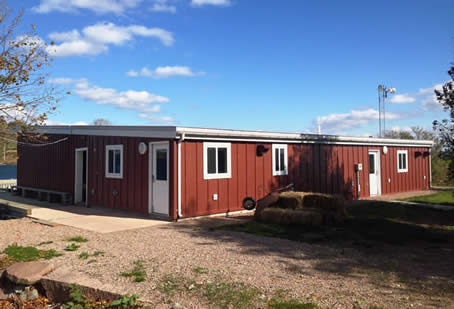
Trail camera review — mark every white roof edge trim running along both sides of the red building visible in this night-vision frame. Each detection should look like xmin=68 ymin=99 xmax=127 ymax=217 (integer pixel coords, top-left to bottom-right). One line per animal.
xmin=34 ymin=126 xmax=433 ymax=147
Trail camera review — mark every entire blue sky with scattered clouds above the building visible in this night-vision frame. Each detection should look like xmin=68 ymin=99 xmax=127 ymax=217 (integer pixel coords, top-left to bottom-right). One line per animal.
xmin=10 ymin=0 xmax=454 ymax=135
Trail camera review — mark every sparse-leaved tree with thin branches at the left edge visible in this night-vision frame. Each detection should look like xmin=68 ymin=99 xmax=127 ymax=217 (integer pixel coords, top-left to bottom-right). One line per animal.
xmin=0 ymin=1 xmax=58 ymax=137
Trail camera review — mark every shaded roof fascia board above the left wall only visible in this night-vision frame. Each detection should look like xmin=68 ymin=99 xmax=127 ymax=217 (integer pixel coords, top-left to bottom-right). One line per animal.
xmin=37 ymin=126 xmax=176 ymax=139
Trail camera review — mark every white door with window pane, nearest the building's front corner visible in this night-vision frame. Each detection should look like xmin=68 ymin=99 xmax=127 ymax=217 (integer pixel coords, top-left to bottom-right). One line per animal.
xmin=150 ymin=142 xmax=169 ymax=216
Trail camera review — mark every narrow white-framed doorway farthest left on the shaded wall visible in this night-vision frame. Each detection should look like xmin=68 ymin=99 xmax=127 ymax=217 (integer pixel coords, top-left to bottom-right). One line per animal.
xmin=74 ymin=148 xmax=88 ymax=205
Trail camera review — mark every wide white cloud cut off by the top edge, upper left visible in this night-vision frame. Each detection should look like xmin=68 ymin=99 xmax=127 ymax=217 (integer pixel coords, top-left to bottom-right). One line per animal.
xmin=32 ymin=0 xmax=142 ymax=15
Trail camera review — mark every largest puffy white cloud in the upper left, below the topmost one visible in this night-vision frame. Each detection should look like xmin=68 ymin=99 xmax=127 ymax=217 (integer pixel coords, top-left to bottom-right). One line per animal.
xmin=48 ymin=23 xmax=175 ymax=57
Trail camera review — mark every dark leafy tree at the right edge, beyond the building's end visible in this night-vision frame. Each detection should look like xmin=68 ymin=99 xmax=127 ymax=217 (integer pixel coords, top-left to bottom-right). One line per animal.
xmin=433 ymin=66 xmax=454 ymax=180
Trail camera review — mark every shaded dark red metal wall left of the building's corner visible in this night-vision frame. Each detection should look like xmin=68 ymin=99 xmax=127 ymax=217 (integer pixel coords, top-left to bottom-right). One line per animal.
xmin=17 ymin=135 xmax=176 ymax=217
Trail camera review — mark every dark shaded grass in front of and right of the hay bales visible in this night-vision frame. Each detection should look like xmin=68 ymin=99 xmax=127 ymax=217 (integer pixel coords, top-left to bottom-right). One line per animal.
xmin=214 ymin=201 xmax=454 ymax=246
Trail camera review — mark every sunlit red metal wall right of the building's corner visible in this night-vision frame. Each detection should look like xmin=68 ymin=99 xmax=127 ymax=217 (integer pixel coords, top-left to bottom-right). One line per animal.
xmin=182 ymin=141 xmax=429 ymax=217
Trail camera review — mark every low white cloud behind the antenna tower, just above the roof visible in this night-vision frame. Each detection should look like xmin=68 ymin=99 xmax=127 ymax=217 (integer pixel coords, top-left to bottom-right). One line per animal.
xmin=314 ymin=108 xmax=401 ymax=133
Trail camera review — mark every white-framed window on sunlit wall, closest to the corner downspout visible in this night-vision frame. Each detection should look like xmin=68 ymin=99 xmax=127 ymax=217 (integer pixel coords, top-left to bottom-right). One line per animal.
xmin=203 ymin=143 xmax=232 ymax=179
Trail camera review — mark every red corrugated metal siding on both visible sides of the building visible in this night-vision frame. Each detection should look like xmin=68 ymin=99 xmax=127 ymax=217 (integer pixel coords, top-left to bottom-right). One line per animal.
xmin=17 ymin=135 xmax=430 ymax=218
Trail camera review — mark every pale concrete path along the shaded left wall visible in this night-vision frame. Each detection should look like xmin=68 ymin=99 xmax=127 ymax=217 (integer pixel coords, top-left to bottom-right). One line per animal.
xmin=0 ymin=193 xmax=170 ymax=233
